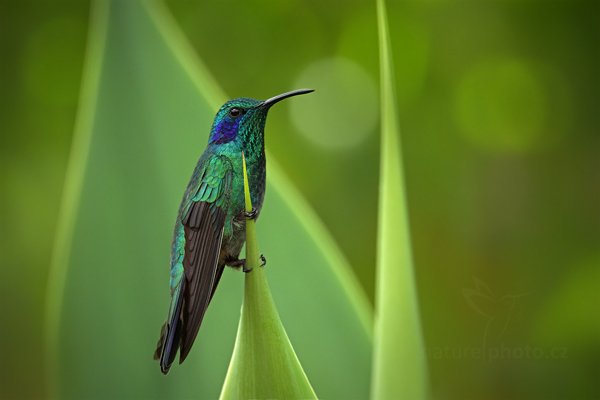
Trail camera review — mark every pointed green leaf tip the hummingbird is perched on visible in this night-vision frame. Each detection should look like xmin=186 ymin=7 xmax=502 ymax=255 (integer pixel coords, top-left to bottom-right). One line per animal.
xmin=221 ymin=155 xmax=317 ymax=400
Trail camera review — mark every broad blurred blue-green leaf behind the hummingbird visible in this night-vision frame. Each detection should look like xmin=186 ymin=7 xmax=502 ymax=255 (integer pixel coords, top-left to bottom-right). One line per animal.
xmin=47 ymin=0 xmax=371 ymax=399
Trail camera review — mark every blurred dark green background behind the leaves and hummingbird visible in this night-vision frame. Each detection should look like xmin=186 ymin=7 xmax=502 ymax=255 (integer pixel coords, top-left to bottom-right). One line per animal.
xmin=0 ymin=0 xmax=600 ymax=399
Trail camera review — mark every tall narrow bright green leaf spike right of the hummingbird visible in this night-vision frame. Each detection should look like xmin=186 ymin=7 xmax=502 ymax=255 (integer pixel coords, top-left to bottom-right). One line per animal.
xmin=371 ymin=0 xmax=427 ymax=400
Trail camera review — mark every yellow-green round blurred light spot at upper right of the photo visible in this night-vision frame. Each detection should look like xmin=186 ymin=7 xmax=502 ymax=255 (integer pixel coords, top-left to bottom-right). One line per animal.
xmin=455 ymin=58 xmax=546 ymax=152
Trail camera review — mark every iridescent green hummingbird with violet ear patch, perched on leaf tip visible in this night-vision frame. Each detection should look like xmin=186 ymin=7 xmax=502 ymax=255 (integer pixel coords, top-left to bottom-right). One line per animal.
xmin=154 ymin=89 xmax=313 ymax=375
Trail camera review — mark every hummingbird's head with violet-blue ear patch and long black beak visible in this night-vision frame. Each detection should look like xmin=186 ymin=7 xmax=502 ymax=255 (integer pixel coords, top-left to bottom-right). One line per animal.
xmin=208 ymin=89 xmax=313 ymax=144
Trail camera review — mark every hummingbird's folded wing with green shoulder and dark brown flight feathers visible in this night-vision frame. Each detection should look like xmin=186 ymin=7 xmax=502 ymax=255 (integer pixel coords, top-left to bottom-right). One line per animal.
xmin=154 ymin=155 xmax=233 ymax=374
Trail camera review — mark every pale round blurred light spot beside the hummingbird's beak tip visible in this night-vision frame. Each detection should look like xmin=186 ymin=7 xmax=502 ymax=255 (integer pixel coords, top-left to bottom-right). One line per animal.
xmin=290 ymin=58 xmax=378 ymax=149
